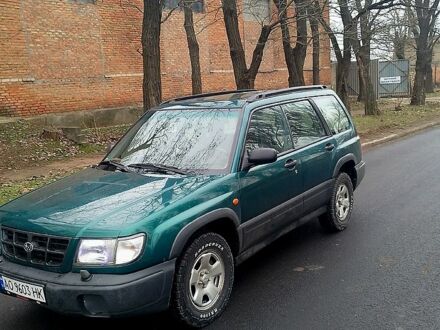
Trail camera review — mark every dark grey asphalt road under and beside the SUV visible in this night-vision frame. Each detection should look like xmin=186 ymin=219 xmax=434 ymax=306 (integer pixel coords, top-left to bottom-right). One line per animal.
xmin=0 ymin=129 xmax=440 ymax=330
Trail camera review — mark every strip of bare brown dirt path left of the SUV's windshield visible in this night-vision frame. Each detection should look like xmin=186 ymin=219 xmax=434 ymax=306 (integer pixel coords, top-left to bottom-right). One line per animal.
xmin=0 ymin=154 xmax=104 ymax=183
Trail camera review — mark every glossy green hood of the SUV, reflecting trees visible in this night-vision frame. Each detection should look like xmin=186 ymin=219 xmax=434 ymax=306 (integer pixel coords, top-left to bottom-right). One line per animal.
xmin=0 ymin=168 xmax=218 ymax=237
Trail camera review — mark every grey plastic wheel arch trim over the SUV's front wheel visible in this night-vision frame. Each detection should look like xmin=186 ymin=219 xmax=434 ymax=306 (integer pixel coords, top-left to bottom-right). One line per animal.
xmin=170 ymin=208 xmax=242 ymax=259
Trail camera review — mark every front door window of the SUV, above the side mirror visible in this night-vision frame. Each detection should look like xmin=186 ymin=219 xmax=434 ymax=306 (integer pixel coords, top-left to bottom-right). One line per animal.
xmin=246 ymin=107 xmax=293 ymax=153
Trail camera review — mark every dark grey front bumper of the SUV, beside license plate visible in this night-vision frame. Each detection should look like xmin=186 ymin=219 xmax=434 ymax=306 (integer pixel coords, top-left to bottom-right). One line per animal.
xmin=0 ymin=257 xmax=175 ymax=317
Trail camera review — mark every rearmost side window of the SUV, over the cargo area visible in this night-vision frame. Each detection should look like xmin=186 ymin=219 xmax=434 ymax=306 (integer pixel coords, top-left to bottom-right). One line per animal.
xmin=313 ymin=95 xmax=351 ymax=134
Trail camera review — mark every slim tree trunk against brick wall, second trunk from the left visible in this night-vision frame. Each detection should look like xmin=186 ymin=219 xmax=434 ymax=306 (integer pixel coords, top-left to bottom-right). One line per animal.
xmin=183 ymin=0 xmax=202 ymax=94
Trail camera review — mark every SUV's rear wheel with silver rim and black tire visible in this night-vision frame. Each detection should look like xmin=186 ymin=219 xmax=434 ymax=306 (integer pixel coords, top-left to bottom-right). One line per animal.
xmin=319 ymin=173 xmax=354 ymax=232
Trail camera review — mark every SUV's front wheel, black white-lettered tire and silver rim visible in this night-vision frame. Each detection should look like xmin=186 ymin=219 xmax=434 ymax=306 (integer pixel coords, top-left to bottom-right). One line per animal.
xmin=171 ymin=233 xmax=234 ymax=328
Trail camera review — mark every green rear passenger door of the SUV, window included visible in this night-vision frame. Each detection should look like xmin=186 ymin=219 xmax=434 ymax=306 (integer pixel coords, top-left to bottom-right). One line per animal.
xmin=281 ymin=99 xmax=335 ymax=213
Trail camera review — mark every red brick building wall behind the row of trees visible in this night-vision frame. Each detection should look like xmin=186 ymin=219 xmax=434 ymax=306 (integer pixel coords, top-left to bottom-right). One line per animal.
xmin=0 ymin=0 xmax=330 ymax=116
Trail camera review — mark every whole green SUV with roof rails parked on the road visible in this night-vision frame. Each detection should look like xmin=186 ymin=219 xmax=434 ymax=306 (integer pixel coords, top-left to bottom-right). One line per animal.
xmin=0 ymin=86 xmax=365 ymax=327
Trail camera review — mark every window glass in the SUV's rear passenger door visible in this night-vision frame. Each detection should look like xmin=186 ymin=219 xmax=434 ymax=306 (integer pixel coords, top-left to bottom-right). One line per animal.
xmin=281 ymin=101 xmax=326 ymax=149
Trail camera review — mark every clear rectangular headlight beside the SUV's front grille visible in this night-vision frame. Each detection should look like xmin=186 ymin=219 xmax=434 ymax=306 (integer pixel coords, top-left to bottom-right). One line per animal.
xmin=76 ymin=234 xmax=145 ymax=265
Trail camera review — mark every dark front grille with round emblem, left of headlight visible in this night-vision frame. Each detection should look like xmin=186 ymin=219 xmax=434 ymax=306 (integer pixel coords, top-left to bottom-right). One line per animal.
xmin=1 ymin=227 xmax=69 ymax=266
